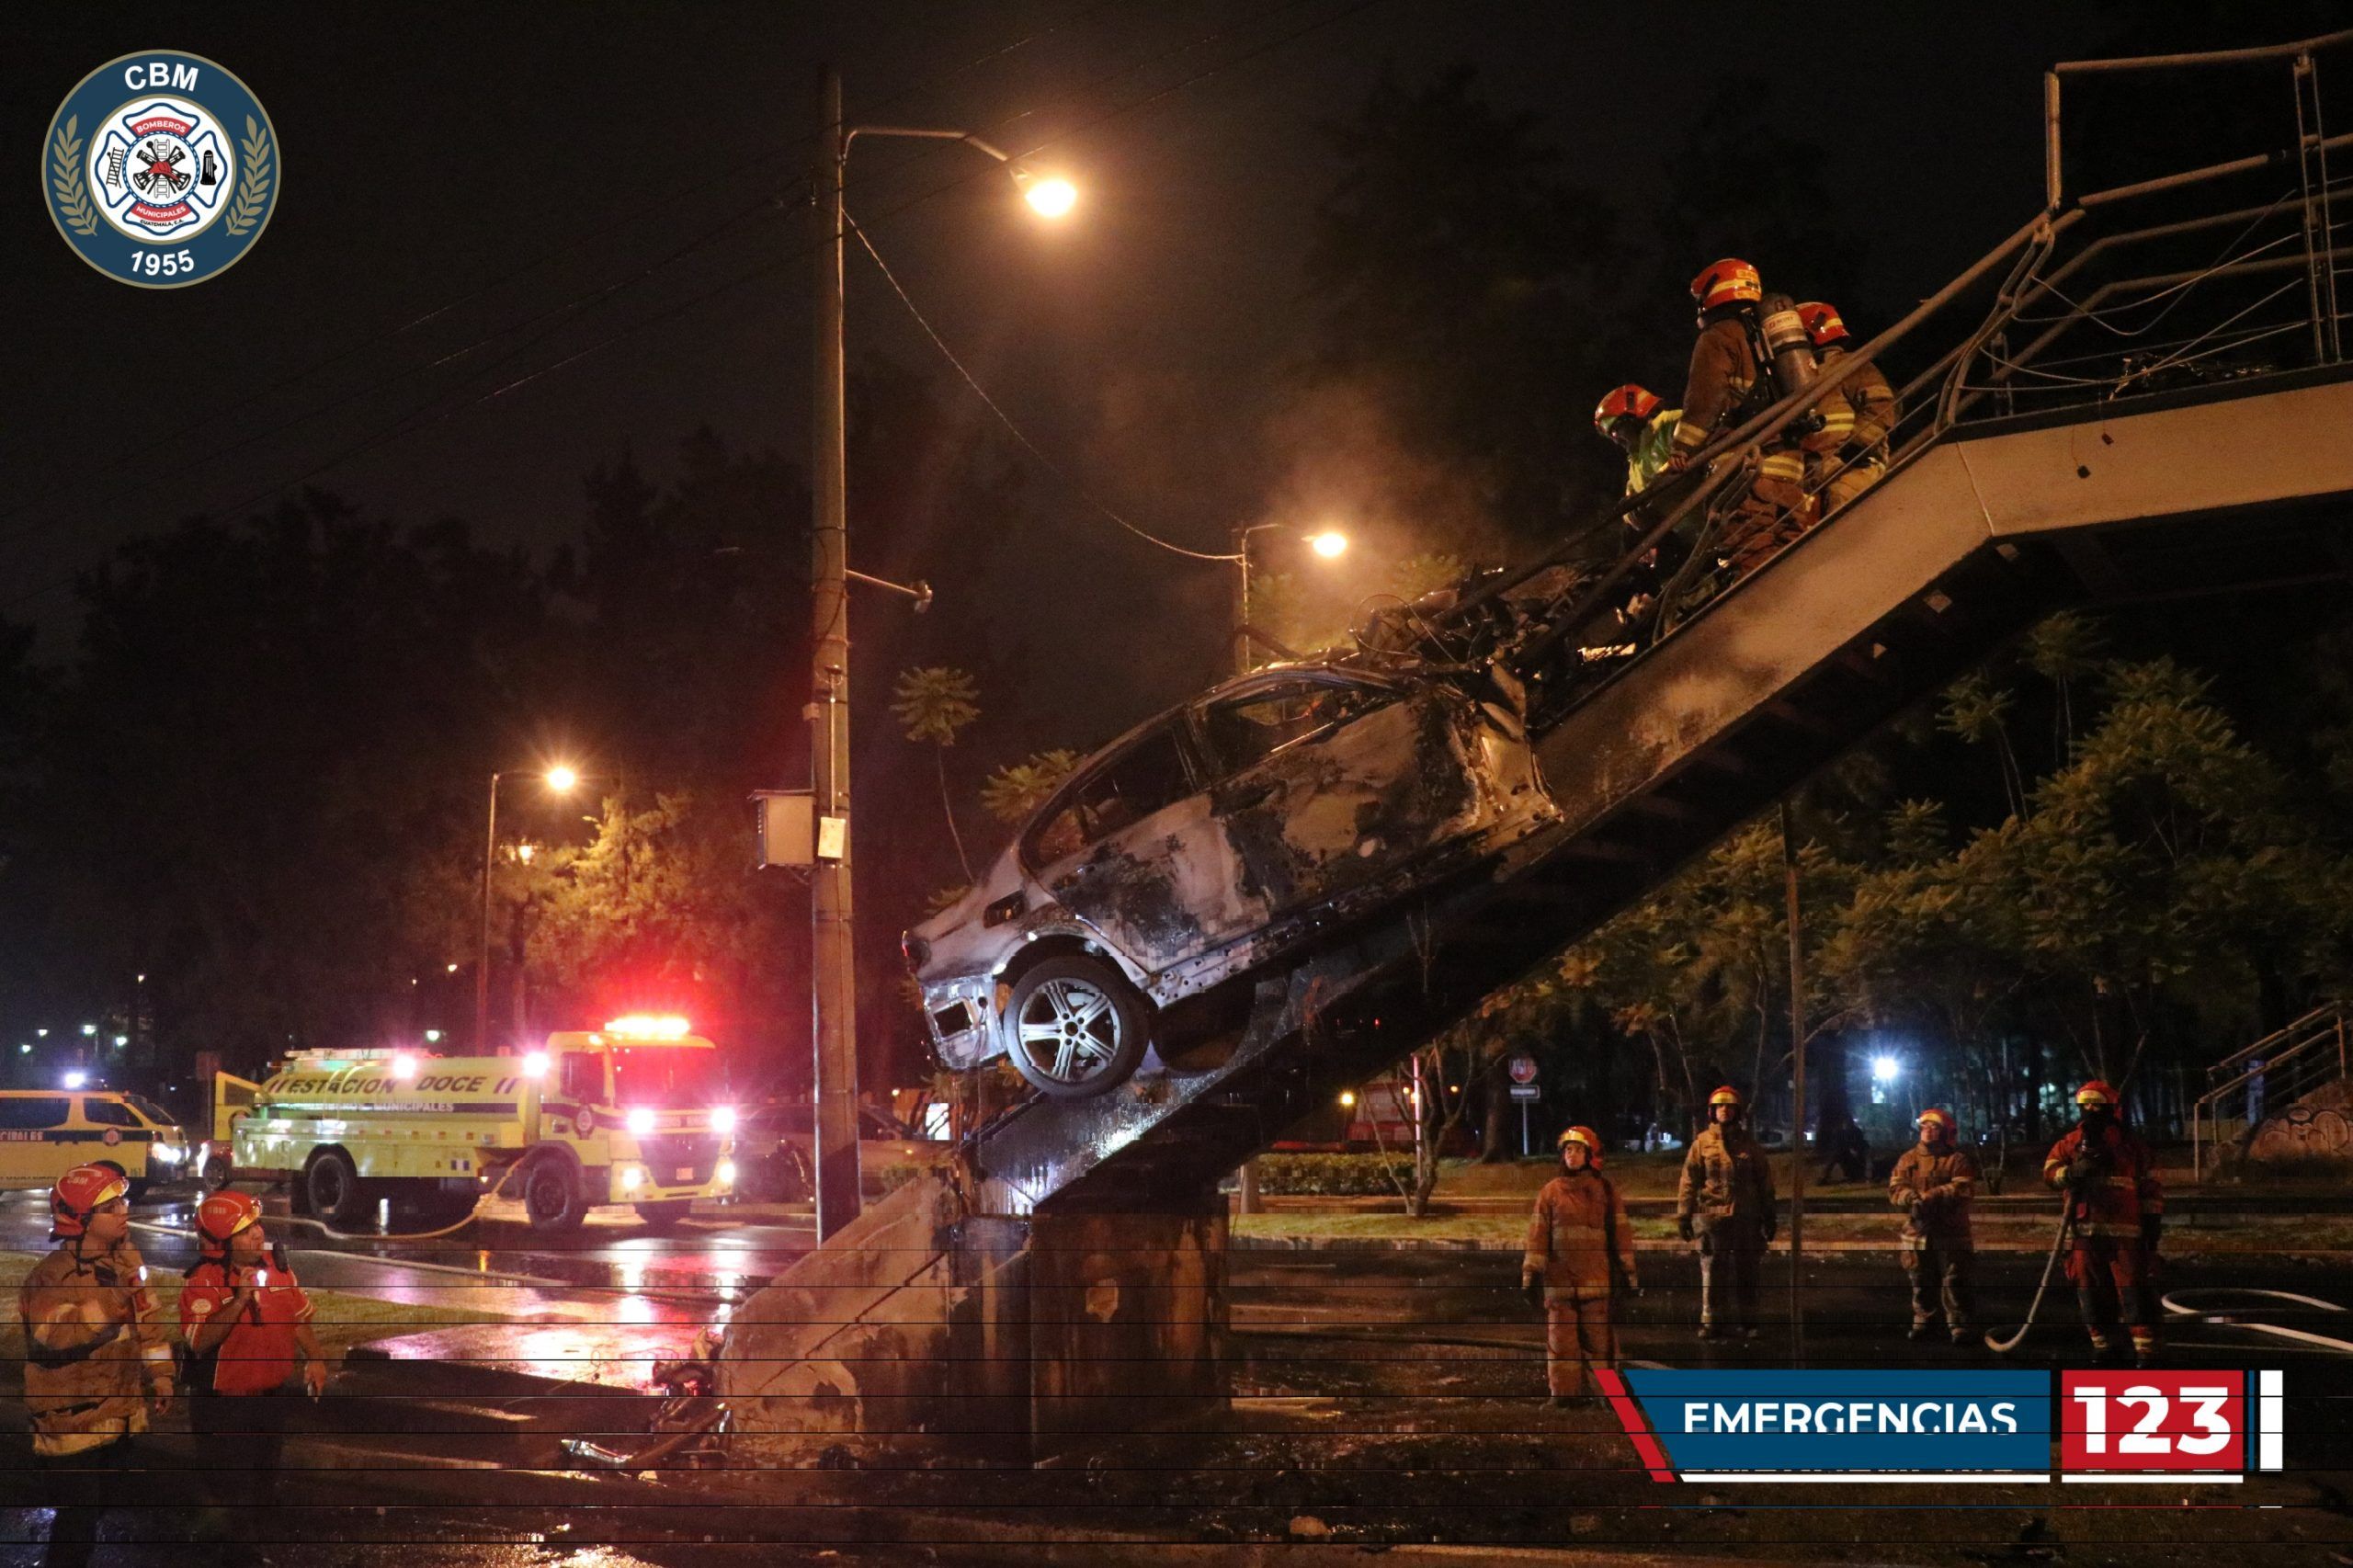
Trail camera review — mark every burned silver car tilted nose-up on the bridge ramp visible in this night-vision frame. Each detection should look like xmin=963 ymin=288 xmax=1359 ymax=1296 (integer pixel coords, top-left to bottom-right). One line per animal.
xmin=906 ymin=662 xmax=1558 ymax=1099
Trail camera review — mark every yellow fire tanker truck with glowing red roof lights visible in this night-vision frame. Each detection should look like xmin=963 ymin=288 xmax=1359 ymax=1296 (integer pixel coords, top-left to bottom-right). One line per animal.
xmin=219 ymin=1017 xmax=734 ymax=1232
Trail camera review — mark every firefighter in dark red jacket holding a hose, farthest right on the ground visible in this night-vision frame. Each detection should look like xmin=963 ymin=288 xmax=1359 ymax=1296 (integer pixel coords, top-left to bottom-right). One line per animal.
xmin=2042 ymin=1078 xmax=2165 ymax=1366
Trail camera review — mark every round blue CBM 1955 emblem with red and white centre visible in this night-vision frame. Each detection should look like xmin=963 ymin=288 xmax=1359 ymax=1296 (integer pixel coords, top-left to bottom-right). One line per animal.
xmin=42 ymin=50 xmax=280 ymax=290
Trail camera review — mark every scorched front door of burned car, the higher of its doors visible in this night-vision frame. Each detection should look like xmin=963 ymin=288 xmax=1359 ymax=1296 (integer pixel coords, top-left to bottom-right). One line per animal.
xmin=1200 ymin=671 xmax=1478 ymax=918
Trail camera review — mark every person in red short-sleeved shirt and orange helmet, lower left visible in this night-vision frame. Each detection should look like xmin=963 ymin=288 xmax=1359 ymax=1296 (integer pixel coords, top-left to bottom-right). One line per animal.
xmin=179 ymin=1191 xmax=332 ymax=1502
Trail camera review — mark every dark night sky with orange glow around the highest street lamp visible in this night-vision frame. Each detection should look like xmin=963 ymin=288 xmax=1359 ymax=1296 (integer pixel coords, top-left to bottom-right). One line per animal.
xmin=0 ymin=0 xmax=2154 ymax=724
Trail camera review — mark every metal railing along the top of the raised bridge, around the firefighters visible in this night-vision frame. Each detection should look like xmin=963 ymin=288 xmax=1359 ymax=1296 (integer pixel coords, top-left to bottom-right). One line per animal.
xmin=1430 ymin=30 xmax=2353 ymax=728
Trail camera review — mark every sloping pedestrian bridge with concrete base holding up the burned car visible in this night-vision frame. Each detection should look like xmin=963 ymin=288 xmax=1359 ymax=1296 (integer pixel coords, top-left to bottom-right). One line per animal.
xmin=722 ymin=40 xmax=2353 ymax=1462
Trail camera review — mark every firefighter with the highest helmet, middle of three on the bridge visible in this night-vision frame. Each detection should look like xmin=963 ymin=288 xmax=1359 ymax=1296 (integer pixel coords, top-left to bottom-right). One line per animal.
xmin=1665 ymin=256 xmax=1807 ymax=572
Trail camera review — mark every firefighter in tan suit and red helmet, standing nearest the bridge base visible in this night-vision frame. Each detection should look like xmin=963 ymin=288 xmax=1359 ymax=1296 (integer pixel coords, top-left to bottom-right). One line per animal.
xmin=1520 ymin=1128 xmax=1638 ymax=1410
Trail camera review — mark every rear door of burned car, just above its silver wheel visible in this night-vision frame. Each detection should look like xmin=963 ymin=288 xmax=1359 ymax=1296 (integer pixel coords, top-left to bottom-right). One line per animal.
xmin=1021 ymin=716 xmax=1266 ymax=974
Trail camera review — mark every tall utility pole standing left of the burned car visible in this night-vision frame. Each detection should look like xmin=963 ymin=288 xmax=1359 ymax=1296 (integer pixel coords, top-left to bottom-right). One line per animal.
xmin=807 ymin=66 xmax=858 ymax=1244
